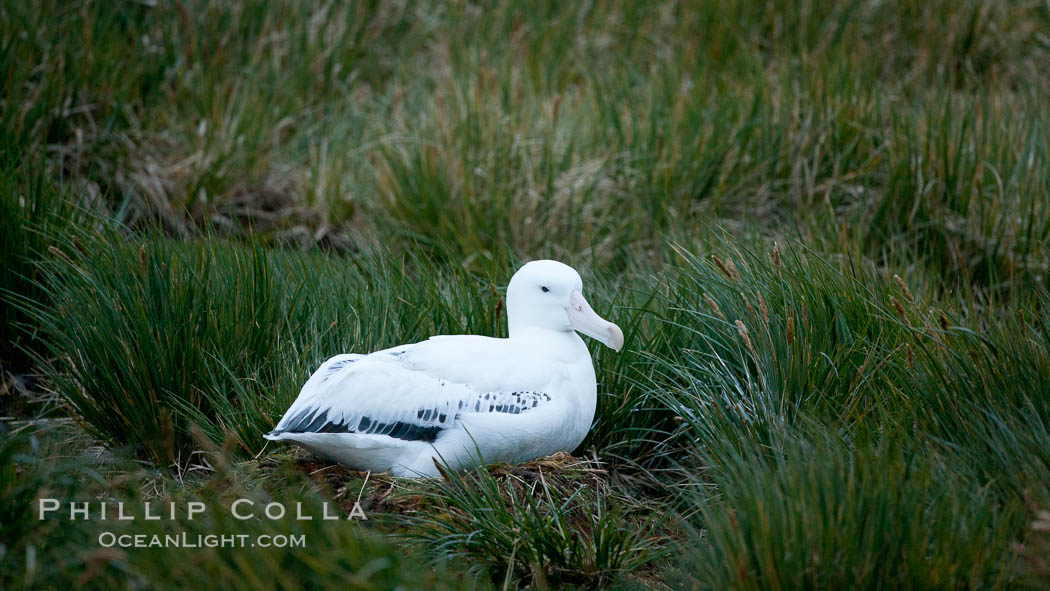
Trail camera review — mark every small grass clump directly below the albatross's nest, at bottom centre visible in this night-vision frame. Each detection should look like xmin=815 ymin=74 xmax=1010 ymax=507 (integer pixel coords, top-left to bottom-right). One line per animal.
xmin=403 ymin=455 xmax=664 ymax=588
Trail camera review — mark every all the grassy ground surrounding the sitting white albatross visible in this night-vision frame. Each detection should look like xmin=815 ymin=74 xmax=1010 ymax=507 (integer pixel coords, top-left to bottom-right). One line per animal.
xmin=0 ymin=0 xmax=1050 ymax=589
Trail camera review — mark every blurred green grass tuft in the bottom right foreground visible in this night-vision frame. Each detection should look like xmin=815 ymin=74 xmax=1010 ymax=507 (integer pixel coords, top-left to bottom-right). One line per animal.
xmin=683 ymin=435 xmax=1019 ymax=589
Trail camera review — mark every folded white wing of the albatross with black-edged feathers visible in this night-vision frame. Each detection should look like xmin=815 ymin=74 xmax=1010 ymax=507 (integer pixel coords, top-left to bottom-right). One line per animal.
xmin=266 ymin=336 xmax=551 ymax=469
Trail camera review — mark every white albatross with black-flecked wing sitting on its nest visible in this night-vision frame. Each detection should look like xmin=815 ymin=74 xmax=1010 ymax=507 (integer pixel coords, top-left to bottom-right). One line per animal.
xmin=266 ymin=260 xmax=624 ymax=477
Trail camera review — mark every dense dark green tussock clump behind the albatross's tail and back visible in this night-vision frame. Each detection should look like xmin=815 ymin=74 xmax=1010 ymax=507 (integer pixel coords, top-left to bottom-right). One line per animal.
xmin=28 ymin=232 xmax=512 ymax=464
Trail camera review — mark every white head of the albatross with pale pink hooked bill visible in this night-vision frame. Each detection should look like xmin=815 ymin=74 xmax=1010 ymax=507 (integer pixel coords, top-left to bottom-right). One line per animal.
xmin=507 ymin=260 xmax=624 ymax=351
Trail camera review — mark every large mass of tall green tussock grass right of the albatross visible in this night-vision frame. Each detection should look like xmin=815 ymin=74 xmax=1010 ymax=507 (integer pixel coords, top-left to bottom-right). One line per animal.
xmin=638 ymin=240 xmax=1050 ymax=589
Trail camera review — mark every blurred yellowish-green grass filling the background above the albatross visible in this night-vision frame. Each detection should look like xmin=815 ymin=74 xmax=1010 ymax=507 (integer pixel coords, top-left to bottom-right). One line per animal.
xmin=0 ymin=0 xmax=1050 ymax=277
